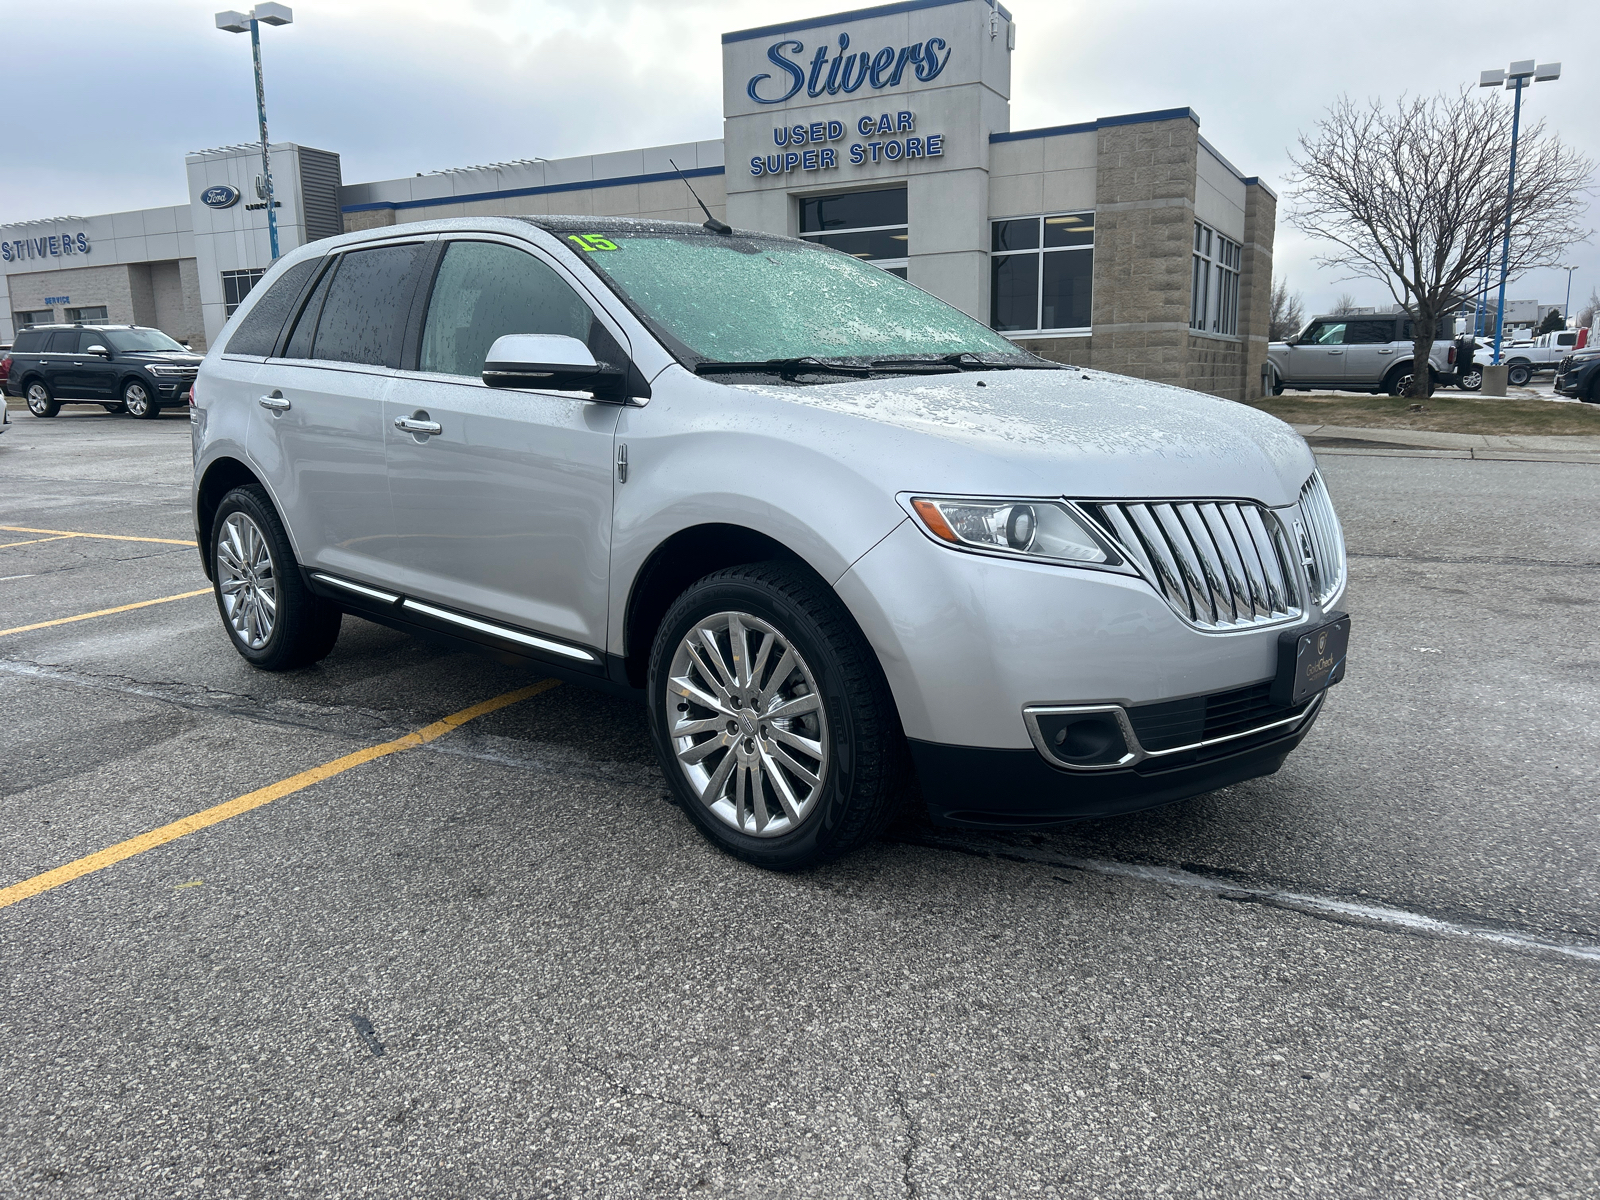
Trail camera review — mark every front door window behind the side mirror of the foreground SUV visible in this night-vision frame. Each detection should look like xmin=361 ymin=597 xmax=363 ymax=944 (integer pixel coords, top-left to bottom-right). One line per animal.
xmin=418 ymin=242 xmax=603 ymax=378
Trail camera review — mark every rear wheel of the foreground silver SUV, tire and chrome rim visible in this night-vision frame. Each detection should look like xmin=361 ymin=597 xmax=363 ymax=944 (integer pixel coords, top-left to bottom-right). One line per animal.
xmin=210 ymin=485 xmax=342 ymax=670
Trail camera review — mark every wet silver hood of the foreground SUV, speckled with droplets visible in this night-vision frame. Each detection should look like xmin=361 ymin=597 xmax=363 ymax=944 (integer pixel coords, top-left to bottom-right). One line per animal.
xmin=739 ymin=370 xmax=1315 ymax=506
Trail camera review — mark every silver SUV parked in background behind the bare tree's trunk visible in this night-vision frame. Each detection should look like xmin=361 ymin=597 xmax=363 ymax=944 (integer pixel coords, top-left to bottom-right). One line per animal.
xmin=1267 ymin=314 xmax=1465 ymax=395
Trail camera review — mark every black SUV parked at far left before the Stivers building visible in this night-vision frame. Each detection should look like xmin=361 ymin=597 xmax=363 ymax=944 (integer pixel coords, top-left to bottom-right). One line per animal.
xmin=5 ymin=325 xmax=200 ymax=418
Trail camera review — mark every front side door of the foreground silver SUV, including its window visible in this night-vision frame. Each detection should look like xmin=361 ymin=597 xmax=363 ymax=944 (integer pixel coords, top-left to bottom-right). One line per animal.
xmin=384 ymin=235 xmax=626 ymax=648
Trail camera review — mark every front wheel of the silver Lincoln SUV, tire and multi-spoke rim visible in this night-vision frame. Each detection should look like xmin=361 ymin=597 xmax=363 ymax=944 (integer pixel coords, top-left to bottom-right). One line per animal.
xmin=646 ymin=562 xmax=909 ymax=870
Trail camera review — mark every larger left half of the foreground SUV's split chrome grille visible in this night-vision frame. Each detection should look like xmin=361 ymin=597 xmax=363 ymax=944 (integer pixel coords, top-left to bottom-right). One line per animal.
xmin=1080 ymin=501 xmax=1301 ymax=629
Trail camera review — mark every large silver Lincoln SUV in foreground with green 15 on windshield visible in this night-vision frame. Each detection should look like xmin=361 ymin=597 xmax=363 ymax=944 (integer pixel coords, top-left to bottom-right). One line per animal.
xmin=194 ymin=218 xmax=1349 ymax=869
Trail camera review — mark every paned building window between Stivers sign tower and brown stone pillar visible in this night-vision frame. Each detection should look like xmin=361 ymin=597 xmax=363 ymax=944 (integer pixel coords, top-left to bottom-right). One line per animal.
xmin=989 ymin=213 xmax=1094 ymax=333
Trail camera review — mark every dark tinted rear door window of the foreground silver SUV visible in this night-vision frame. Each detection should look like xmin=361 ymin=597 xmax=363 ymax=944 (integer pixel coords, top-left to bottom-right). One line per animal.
xmin=310 ymin=245 xmax=424 ymax=366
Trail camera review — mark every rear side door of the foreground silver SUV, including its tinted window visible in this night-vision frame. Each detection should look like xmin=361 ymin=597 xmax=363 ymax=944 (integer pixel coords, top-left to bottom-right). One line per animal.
xmin=246 ymin=240 xmax=429 ymax=582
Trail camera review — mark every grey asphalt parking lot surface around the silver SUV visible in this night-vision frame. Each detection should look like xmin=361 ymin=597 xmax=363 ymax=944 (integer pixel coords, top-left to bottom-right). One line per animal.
xmin=0 ymin=408 xmax=1600 ymax=1197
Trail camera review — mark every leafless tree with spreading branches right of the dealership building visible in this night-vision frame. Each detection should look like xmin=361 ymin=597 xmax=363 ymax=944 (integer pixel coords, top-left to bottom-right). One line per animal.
xmin=1290 ymin=88 xmax=1594 ymax=397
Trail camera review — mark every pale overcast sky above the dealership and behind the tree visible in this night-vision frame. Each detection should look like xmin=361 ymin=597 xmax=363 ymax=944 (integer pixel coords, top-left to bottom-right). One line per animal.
xmin=0 ymin=0 xmax=1600 ymax=320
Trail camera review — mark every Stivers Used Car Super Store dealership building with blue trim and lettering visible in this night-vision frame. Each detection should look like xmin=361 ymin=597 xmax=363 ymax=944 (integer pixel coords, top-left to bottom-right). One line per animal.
xmin=0 ymin=0 xmax=1277 ymax=400
